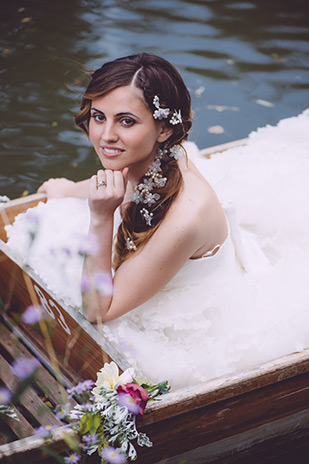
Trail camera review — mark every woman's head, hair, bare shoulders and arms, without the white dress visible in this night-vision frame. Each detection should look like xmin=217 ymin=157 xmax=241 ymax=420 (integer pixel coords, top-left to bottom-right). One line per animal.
xmin=39 ymin=53 xmax=228 ymax=322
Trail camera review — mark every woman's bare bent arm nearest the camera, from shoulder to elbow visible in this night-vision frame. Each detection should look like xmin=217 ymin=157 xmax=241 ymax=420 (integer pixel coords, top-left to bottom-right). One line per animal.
xmin=84 ymin=176 xmax=220 ymax=323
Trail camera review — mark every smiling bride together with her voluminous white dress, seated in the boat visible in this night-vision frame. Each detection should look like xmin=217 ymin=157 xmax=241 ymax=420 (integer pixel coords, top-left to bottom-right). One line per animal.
xmin=8 ymin=53 xmax=309 ymax=388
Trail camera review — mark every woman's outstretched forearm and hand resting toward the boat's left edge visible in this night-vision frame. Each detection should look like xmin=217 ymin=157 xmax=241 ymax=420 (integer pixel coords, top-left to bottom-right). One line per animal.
xmin=38 ymin=177 xmax=90 ymax=199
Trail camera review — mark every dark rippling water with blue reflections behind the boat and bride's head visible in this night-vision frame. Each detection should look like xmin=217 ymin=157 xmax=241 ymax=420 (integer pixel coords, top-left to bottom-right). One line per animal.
xmin=0 ymin=0 xmax=309 ymax=198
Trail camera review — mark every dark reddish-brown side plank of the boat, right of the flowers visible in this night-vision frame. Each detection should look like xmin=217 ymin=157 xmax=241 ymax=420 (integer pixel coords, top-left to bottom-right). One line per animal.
xmin=137 ymin=373 xmax=309 ymax=464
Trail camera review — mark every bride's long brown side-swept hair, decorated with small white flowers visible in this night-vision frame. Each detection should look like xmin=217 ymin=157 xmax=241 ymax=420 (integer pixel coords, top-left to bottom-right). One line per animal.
xmin=75 ymin=53 xmax=192 ymax=269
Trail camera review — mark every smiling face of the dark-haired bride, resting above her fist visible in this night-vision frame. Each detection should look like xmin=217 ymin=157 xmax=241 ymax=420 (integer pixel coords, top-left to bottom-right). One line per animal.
xmin=89 ymin=86 xmax=171 ymax=176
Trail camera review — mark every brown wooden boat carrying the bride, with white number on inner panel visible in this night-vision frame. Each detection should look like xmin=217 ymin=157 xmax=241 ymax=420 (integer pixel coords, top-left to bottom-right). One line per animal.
xmin=0 ymin=139 xmax=309 ymax=464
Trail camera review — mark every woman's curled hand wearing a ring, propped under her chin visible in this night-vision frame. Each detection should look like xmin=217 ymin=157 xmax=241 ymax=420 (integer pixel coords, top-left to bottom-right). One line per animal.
xmin=89 ymin=168 xmax=128 ymax=221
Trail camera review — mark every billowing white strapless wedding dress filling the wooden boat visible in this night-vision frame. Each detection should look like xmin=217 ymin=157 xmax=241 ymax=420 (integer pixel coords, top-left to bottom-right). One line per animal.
xmin=7 ymin=110 xmax=309 ymax=389
